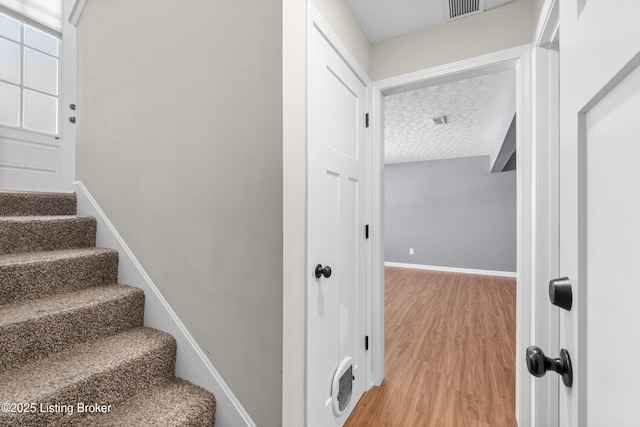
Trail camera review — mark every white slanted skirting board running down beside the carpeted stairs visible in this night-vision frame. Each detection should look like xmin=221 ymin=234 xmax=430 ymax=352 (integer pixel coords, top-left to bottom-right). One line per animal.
xmin=72 ymin=181 xmax=256 ymax=427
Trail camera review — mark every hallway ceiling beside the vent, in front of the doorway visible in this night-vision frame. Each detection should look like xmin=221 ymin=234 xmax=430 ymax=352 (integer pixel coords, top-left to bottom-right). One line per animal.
xmin=346 ymin=0 xmax=513 ymax=43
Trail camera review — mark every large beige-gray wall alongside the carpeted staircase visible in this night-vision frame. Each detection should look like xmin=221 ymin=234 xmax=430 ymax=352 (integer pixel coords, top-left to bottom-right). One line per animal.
xmin=77 ymin=0 xmax=283 ymax=427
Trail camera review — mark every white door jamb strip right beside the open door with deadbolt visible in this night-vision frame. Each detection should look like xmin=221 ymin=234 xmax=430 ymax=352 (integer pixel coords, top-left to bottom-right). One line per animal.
xmin=530 ymin=0 xmax=560 ymax=427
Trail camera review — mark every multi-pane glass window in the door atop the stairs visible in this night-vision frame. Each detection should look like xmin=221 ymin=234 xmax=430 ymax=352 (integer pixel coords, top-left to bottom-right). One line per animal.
xmin=0 ymin=12 xmax=60 ymax=135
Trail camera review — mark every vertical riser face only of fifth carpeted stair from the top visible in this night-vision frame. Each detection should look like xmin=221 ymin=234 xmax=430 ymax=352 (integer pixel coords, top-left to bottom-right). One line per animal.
xmin=0 ymin=340 xmax=176 ymax=427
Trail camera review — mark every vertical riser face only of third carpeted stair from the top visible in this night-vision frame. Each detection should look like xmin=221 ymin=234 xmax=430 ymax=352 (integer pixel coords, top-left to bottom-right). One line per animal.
xmin=0 ymin=251 xmax=118 ymax=304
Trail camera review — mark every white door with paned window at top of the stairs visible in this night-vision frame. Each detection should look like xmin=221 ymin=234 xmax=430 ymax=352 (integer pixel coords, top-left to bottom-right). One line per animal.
xmin=0 ymin=0 xmax=76 ymax=191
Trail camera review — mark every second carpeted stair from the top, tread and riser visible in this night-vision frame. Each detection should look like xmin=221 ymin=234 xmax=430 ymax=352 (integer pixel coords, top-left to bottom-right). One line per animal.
xmin=0 ymin=215 xmax=96 ymax=254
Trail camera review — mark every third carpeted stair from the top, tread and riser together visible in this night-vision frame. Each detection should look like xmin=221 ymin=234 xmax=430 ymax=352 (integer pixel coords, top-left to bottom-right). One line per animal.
xmin=0 ymin=247 xmax=118 ymax=306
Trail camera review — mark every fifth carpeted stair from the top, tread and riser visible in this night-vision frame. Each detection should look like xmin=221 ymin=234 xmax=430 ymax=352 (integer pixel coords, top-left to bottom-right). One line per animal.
xmin=0 ymin=327 xmax=176 ymax=425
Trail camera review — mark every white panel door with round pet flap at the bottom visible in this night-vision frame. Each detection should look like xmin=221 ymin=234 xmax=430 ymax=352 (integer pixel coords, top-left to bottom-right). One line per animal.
xmin=307 ymin=21 xmax=366 ymax=427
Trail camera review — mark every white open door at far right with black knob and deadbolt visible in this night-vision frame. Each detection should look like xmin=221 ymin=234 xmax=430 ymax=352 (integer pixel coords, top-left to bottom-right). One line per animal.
xmin=552 ymin=0 xmax=640 ymax=427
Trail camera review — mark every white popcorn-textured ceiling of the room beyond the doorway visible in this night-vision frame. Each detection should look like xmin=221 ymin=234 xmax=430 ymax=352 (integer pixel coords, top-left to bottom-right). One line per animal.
xmin=384 ymin=70 xmax=515 ymax=163
